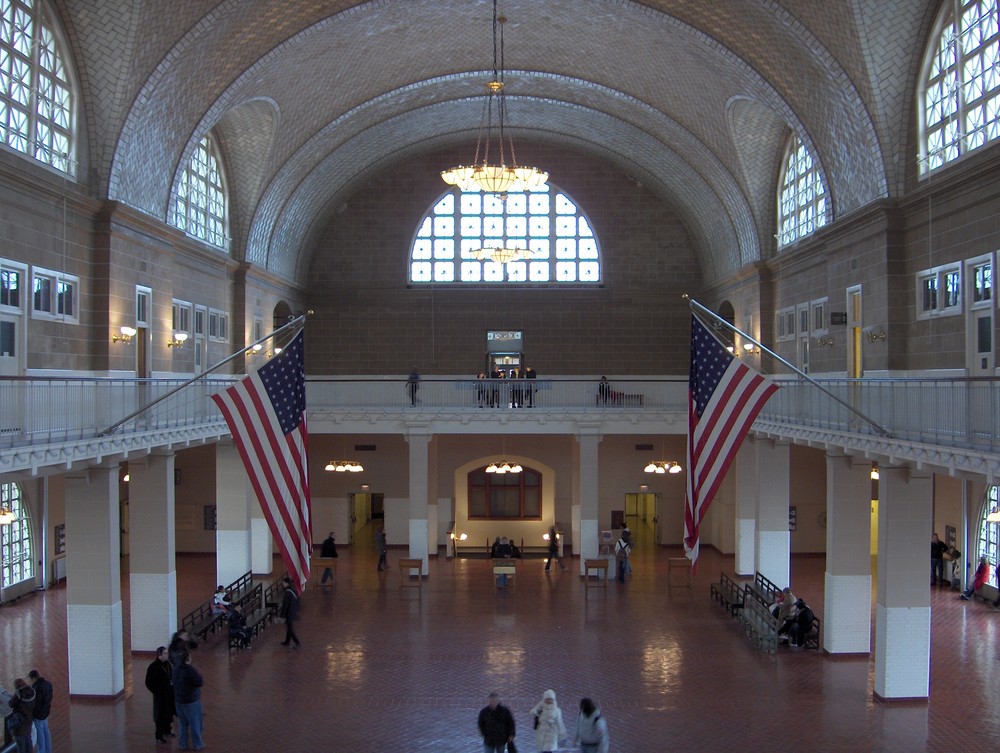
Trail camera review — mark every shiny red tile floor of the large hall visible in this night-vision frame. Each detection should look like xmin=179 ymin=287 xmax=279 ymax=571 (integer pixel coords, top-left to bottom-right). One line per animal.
xmin=0 ymin=525 xmax=1000 ymax=753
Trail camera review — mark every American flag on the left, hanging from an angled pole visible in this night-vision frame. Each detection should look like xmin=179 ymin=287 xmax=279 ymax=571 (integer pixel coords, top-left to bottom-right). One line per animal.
xmin=212 ymin=332 xmax=312 ymax=591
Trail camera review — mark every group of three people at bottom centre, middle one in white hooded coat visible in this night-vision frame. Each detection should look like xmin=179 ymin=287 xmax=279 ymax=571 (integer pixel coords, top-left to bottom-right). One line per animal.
xmin=479 ymin=690 xmax=608 ymax=753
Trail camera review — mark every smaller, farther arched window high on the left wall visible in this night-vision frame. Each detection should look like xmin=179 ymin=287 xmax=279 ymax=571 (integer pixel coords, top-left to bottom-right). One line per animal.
xmin=171 ymin=136 xmax=229 ymax=248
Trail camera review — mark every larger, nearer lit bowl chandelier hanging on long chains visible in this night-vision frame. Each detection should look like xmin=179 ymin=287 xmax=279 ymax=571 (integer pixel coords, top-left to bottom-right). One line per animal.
xmin=441 ymin=0 xmax=549 ymax=197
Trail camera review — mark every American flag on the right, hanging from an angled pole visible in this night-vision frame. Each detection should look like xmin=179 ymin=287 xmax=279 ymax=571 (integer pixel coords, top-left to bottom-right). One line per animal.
xmin=684 ymin=316 xmax=778 ymax=566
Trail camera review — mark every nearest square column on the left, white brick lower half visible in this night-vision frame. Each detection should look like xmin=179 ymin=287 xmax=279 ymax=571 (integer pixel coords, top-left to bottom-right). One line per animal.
xmin=66 ymin=465 xmax=125 ymax=696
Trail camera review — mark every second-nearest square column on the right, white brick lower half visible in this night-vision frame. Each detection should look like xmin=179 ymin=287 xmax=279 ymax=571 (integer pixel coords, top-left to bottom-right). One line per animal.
xmin=823 ymin=452 xmax=872 ymax=654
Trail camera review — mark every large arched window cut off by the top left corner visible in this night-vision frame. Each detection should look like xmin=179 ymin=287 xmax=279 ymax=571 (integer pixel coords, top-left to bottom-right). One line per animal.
xmin=0 ymin=0 xmax=76 ymax=175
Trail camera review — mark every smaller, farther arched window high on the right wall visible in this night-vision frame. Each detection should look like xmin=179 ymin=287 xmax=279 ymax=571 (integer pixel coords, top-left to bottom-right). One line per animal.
xmin=778 ymin=134 xmax=830 ymax=247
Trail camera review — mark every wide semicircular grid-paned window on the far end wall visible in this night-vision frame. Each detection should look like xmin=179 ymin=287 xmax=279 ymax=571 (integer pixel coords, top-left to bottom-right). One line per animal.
xmin=409 ymin=182 xmax=601 ymax=285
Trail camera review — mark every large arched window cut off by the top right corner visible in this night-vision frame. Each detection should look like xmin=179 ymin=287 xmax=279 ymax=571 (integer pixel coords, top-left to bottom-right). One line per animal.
xmin=917 ymin=0 xmax=1000 ymax=175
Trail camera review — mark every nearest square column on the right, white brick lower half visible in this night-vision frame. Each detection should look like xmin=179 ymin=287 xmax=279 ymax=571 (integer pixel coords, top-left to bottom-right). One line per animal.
xmin=875 ymin=464 xmax=934 ymax=699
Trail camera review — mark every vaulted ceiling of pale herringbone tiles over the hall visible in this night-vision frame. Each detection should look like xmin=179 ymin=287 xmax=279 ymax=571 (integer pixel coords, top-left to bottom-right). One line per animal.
xmin=72 ymin=0 xmax=938 ymax=283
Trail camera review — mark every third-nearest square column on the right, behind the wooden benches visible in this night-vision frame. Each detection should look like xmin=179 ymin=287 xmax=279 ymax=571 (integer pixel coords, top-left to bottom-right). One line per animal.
xmin=754 ymin=440 xmax=794 ymax=590
